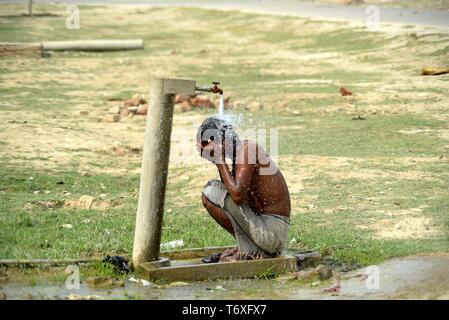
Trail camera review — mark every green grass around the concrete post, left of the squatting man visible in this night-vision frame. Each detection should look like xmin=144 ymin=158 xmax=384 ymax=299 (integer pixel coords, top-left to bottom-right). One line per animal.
xmin=0 ymin=165 xmax=232 ymax=258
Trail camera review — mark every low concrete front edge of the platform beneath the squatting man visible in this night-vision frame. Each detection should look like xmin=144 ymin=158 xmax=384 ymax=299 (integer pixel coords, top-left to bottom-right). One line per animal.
xmin=138 ymin=256 xmax=296 ymax=281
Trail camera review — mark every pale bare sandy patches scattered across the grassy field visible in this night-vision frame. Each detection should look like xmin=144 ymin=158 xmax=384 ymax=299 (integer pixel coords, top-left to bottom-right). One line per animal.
xmin=0 ymin=5 xmax=449 ymax=242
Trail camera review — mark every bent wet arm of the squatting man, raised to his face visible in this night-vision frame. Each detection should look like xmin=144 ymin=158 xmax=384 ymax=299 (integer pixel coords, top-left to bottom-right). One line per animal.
xmin=217 ymin=144 xmax=256 ymax=204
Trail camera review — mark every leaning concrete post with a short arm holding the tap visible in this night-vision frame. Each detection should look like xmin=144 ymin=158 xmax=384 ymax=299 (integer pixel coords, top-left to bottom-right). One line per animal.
xmin=133 ymin=77 xmax=196 ymax=266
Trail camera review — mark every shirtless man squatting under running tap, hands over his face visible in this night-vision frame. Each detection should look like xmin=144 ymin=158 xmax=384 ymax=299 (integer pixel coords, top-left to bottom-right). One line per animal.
xmin=197 ymin=117 xmax=290 ymax=262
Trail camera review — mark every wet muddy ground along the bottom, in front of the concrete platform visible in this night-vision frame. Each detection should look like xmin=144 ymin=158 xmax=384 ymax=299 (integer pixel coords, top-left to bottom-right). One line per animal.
xmin=0 ymin=255 xmax=449 ymax=299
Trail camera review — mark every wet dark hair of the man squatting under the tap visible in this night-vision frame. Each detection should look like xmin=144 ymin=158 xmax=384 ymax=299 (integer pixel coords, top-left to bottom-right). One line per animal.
xmin=197 ymin=116 xmax=238 ymax=176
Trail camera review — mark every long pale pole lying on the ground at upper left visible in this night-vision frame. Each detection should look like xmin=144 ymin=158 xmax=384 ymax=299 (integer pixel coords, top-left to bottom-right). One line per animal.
xmin=42 ymin=40 xmax=144 ymax=51
